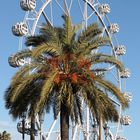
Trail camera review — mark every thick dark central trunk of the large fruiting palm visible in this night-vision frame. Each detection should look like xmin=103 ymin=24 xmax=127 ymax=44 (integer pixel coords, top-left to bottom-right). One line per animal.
xmin=60 ymin=103 xmax=69 ymax=140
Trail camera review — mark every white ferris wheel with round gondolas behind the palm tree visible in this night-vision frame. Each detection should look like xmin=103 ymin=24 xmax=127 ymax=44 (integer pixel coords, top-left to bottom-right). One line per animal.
xmin=9 ymin=0 xmax=132 ymax=140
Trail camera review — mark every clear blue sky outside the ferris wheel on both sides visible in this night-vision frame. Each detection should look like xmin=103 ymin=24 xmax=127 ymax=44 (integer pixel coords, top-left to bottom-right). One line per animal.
xmin=0 ymin=0 xmax=140 ymax=140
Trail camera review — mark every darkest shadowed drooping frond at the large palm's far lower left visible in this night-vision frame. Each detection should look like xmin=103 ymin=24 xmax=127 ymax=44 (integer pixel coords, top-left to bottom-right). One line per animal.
xmin=5 ymin=82 xmax=42 ymax=119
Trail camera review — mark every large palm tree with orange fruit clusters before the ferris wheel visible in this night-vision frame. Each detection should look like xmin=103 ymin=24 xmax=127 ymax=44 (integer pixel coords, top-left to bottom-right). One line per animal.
xmin=5 ymin=15 xmax=128 ymax=140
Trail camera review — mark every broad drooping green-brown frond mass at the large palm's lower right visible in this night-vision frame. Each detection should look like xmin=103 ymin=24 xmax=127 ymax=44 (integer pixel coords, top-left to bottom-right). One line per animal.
xmin=83 ymin=85 xmax=119 ymax=123
